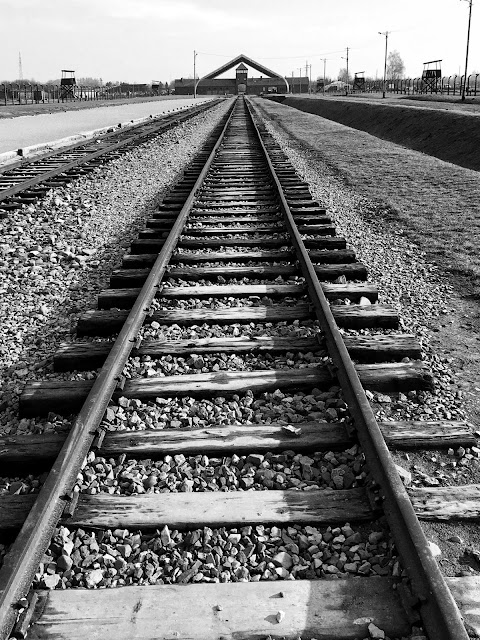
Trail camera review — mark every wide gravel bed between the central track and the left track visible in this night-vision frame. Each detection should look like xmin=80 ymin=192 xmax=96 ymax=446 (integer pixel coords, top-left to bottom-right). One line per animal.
xmin=0 ymin=103 xmax=232 ymax=434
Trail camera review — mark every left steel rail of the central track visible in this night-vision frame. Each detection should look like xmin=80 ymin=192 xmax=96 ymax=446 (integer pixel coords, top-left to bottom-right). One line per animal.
xmin=0 ymin=96 xmax=235 ymax=640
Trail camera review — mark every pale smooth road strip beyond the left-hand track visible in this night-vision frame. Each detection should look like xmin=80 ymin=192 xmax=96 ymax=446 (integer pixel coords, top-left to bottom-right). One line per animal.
xmin=0 ymin=97 xmax=211 ymax=153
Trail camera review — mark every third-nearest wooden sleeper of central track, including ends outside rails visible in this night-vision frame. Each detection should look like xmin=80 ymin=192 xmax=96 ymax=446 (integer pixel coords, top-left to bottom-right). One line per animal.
xmin=0 ymin=421 xmax=476 ymax=464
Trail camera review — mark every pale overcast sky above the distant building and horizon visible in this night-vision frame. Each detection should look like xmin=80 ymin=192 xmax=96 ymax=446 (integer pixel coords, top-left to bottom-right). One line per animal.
xmin=0 ymin=0 xmax=480 ymax=83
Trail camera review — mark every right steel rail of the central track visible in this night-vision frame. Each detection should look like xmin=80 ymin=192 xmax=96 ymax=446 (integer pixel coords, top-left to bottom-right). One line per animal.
xmin=247 ymin=101 xmax=469 ymax=640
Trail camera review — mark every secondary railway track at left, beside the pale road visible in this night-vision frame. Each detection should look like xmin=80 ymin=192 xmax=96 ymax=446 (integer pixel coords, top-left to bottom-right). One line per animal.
xmin=0 ymin=100 xmax=219 ymax=218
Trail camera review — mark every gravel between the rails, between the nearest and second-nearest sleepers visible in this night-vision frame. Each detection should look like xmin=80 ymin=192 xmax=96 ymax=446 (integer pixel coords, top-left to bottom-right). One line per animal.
xmin=34 ymin=521 xmax=402 ymax=589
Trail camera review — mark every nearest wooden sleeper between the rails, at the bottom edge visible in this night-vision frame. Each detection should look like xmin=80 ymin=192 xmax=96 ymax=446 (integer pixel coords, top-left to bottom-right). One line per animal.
xmin=28 ymin=578 xmax=410 ymax=640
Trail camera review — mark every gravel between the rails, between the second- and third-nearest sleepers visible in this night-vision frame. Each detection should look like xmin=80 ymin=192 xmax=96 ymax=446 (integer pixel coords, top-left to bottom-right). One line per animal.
xmin=77 ymin=445 xmax=367 ymax=495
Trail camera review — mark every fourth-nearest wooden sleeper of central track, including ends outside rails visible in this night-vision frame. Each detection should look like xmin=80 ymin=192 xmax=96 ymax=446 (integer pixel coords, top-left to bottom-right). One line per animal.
xmin=19 ymin=363 xmax=431 ymax=417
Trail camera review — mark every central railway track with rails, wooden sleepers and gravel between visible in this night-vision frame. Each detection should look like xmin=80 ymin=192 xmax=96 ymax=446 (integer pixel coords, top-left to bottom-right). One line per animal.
xmin=0 ymin=99 xmax=474 ymax=640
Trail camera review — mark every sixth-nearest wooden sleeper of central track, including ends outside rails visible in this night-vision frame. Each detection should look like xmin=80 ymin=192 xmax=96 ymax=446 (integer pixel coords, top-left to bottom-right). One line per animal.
xmin=77 ymin=303 xmax=398 ymax=337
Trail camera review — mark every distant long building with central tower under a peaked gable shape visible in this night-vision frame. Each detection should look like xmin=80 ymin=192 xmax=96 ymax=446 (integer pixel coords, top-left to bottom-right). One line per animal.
xmin=175 ymin=54 xmax=309 ymax=95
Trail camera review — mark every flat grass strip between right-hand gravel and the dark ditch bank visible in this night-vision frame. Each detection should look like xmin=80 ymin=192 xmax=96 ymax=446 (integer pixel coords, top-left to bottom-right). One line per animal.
xmin=258 ymin=100 xmax=480 ymax=296
